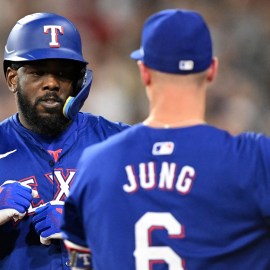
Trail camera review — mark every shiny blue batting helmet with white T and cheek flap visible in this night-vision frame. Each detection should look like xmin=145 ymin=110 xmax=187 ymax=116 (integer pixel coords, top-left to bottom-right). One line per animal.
xmin=4 ymin=13 xmax=92 ymax=119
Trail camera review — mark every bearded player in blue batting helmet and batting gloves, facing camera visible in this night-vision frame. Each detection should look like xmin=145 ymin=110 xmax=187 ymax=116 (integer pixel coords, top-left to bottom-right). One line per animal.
xmin=0 ymin=13 xmax=128 ymax=270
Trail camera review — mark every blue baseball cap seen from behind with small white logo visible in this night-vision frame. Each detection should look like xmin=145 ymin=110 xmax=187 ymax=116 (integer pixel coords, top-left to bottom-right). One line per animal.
xmin=130 ymin=9 xmax=213 ymax=74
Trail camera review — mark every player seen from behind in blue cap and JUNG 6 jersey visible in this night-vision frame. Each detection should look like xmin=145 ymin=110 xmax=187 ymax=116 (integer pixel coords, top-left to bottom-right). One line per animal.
xmin=62 ymin=10 xmax=270 ymax=270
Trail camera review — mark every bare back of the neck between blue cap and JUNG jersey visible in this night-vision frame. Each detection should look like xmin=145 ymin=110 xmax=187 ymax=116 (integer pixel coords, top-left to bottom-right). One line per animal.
xmin=144 ymin=84 xmax=206 ymax=128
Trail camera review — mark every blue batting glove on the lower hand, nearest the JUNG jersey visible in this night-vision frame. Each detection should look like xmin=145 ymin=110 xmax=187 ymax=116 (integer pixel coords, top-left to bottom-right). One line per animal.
xmin=32 ymin=201 xmax=64 ymax=245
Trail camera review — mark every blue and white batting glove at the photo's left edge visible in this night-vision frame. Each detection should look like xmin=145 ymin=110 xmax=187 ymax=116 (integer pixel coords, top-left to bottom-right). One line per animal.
xmin=0 ymin=180 xmax=38 ymax=225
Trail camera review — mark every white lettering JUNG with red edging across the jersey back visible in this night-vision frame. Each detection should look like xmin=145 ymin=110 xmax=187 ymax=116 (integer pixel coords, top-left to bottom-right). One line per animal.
xmin=123 ymin=162 xmax=195 ymax=194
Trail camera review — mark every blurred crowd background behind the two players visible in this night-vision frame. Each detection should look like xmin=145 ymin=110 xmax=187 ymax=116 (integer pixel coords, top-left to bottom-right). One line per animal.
xmin=0 ymin=0 xmax=270 ymax=135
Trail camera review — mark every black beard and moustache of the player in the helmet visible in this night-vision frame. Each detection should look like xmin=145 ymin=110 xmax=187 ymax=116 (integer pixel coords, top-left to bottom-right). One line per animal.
xmin=17 ymin=84 xmax=70 ymax=137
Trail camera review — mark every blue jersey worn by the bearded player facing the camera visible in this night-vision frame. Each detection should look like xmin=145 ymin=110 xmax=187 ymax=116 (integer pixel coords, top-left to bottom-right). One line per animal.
xmin=0 ymin=113 xmax=128 ymax=270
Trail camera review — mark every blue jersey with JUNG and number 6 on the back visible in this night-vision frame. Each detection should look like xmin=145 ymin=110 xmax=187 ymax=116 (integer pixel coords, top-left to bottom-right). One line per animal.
xmin=62 ymin=124 xmax=270 ymax=270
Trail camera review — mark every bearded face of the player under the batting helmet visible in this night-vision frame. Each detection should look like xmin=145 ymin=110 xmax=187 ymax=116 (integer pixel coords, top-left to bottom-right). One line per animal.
xmin=8 ymin=60 xmax=78 ymax=136
